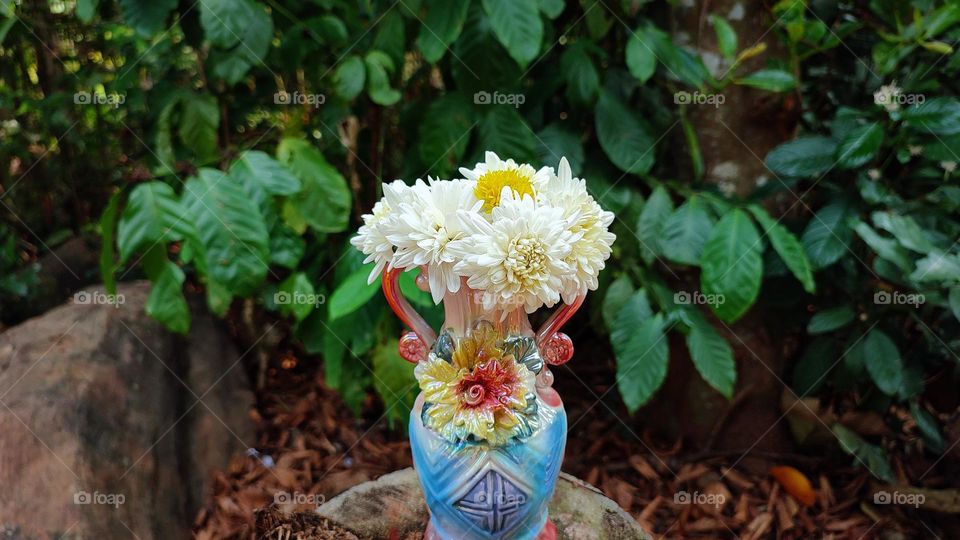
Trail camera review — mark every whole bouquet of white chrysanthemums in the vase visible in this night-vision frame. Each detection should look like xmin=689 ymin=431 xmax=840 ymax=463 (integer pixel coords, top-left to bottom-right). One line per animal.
xmin=351 ymin=152 xmax=616 ymax=313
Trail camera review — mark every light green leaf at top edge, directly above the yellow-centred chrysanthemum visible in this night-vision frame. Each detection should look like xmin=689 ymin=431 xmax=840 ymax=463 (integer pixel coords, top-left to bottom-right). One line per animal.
xmin=482 ymin=0 xmax=543 ymax=68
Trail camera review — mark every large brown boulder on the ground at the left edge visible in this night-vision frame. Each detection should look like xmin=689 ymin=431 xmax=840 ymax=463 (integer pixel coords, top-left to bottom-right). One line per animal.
xmin=0 ymin=282 xmax=254 ymax=540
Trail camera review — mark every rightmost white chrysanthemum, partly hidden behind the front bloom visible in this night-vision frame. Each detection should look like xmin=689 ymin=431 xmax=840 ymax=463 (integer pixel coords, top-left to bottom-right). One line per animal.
xmin=543 ymin=158 xmax=617 ymax=304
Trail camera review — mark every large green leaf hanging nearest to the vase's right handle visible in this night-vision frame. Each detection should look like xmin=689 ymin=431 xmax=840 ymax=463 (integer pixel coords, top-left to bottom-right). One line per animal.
xmin=611 ymin=312 xmax=669 ymax=414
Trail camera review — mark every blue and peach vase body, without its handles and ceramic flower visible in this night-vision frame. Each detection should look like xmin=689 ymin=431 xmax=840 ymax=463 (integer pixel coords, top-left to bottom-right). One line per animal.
xmin=409 ymin=287 xmax=567 ymax=540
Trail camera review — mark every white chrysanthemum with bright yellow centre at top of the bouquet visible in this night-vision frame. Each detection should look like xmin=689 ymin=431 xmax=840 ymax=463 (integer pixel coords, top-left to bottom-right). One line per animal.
xmin=460 ymin=152 xmax=553 ymax=213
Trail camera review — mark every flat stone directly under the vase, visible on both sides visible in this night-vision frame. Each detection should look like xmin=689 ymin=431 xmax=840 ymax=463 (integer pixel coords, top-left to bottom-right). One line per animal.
xmin=317 ymin=469 xmax=650 ymax=540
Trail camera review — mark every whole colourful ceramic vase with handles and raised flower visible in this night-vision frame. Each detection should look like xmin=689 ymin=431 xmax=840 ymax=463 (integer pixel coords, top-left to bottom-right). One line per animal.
xmin=382 ymin=269 xmax=583 ymax=540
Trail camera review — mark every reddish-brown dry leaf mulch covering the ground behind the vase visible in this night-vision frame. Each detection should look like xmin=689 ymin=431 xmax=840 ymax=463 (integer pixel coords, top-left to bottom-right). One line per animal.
xmin=194 ymin=354 xmax=952 ymax=540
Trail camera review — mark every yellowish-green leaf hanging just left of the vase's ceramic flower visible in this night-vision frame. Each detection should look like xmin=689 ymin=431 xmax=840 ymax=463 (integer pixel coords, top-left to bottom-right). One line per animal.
xmin=373 ymin=339 xmax=418 ymax=426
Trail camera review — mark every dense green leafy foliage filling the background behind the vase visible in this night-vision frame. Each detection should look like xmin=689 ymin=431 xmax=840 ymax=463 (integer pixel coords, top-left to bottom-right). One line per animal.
xmin=0 ymin=0 xmax=960 ymax=480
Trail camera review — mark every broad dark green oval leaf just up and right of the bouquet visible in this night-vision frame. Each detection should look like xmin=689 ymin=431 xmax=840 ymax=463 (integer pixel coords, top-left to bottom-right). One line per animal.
xmin=595 ymin=92 xmax=655 ymax=175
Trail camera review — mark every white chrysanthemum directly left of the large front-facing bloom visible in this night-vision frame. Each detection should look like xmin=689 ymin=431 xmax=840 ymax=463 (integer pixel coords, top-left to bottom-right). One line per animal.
xmin=380 ymin=179 xmax=481 ymax=303
